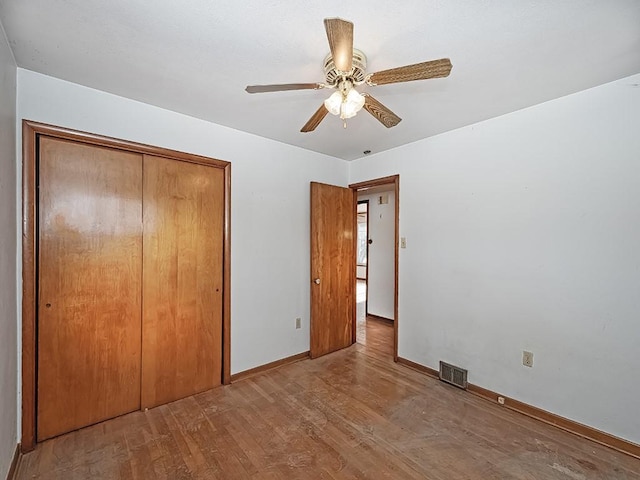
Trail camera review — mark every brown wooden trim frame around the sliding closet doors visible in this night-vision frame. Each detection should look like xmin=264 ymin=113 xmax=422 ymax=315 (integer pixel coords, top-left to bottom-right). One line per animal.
xmin=20 ymin=120 xmax=231 ymax=453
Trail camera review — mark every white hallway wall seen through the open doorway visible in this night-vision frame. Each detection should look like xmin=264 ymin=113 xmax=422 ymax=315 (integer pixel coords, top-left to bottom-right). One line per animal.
xmin=358 ymin=190 xmax=396 ymax=320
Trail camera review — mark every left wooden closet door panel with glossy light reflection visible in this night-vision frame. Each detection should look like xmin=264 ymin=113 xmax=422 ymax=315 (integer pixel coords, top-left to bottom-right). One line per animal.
xmin=37 ymin=137 xmax=142 ymax=441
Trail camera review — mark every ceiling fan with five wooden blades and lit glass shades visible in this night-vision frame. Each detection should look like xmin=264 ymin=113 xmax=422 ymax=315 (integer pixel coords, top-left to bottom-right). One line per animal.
xmin=245 ymin=18 xmax=452 ymax=132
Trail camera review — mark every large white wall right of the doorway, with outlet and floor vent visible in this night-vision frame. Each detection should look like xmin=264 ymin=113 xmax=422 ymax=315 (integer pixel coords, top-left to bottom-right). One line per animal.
xmin=349 ymin=75 xmax=640 ymax=443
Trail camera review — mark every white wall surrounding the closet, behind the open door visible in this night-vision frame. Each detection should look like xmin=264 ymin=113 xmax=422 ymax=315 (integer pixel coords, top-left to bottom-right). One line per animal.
xmin=18 ymin=69 xmax=348 ymax=382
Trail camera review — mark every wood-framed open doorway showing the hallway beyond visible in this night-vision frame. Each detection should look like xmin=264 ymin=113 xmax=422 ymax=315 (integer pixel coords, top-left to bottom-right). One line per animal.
xmin=350 ymin=175 xmax=399 ymax=361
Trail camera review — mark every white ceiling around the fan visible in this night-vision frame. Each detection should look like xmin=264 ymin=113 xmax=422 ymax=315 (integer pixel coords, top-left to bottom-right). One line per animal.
xmin=0 ymin=0 xmax=640 ymax=160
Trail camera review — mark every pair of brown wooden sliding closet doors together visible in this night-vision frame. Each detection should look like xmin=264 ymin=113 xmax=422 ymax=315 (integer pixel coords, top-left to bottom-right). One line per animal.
xmin=36 ymin=136 xmax=225 ymax=441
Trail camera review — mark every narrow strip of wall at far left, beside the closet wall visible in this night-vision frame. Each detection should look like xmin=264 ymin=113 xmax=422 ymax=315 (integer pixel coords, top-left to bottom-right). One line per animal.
xmin=0 ymin=16 xmax=18 ymax=478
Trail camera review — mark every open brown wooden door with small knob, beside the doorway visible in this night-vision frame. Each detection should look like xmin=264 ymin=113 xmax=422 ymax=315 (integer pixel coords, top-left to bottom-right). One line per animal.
xmin=310 ymin=182 xmax=356 ymax=358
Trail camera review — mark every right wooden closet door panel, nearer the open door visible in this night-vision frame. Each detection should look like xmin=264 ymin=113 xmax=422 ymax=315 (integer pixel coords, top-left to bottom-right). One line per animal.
xmin=142 ymin=155 xmax=224 ymax=408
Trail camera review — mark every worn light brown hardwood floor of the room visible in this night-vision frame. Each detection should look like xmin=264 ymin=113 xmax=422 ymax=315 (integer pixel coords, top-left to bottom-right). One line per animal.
xmin=17 ymin=310 xmax=640 ymax=480
